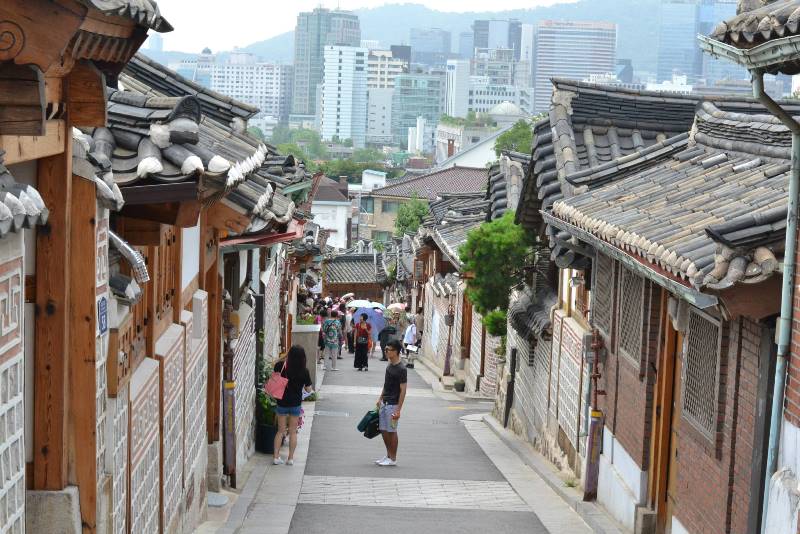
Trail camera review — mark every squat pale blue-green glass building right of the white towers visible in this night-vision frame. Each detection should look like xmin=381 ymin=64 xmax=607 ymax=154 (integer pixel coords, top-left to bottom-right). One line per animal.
xmin=392 ymin=73 xmax=445 ymax=146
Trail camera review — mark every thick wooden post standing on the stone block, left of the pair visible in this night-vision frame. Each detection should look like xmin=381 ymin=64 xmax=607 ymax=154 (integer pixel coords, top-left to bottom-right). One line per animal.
xmin=32 ymin=138 xmax=71 ymax=490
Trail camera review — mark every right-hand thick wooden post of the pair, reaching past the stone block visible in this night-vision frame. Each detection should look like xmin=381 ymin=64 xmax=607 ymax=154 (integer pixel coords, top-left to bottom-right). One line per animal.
xmin=68 ymin=176 xmax=98 ymax=533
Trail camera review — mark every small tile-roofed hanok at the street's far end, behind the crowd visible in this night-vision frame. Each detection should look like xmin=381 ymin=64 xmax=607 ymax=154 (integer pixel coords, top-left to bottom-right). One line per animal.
xmin=322 ymin=252 xmax=386 ymax=303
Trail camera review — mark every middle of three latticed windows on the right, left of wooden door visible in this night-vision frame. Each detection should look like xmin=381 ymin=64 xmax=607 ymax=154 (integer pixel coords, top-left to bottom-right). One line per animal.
xmin=617 ymin=268 xmax=644 ymax=369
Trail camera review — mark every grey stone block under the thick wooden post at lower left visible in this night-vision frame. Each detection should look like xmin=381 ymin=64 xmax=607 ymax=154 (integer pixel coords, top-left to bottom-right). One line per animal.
xmin=25 ymin=486 xmax=82 ymax=534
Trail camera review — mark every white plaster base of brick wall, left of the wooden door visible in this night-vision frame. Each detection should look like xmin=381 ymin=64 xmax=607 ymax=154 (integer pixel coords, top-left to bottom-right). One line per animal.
xmin=597 ymin=427 xmax=648 ymax=532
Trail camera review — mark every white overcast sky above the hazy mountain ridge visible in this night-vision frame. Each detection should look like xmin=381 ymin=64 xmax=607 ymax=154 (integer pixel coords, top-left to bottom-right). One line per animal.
xmin=153 ymin=0 xmax=574 ymax=52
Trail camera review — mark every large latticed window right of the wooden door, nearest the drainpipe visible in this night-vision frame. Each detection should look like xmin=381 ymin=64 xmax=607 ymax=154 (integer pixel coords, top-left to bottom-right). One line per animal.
xmin=681 ymin=308 xmax=722 ymax=441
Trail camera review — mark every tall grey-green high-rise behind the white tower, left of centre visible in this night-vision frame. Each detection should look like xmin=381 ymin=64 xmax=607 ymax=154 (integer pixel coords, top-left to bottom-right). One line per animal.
xmin=292 ymin=8 xmax=361 ymax=115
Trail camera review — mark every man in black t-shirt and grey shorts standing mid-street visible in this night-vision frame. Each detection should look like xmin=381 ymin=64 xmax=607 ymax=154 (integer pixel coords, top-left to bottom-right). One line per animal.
xmin=375 ymin=339 xmax=408 ymax=466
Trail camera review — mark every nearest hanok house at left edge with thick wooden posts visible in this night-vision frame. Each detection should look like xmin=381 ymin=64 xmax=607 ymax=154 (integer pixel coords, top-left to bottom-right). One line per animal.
xmin=0 ymin=0 xmax=178 ymax=532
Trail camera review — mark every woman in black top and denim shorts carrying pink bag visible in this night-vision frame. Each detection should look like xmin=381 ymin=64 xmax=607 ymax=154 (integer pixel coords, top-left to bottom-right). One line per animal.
xmin=268 ymin=345 xmax=312 ymax=465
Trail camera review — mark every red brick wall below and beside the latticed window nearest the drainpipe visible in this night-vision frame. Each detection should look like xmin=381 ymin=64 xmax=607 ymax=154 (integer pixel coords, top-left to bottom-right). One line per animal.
xmin=675 ymin=319 xmax=761 ymax=534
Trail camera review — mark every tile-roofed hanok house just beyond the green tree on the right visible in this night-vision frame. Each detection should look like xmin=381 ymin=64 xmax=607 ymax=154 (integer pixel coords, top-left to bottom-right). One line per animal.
xmin=415 ymin=191 xmax=501 ymax=396
